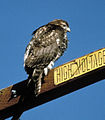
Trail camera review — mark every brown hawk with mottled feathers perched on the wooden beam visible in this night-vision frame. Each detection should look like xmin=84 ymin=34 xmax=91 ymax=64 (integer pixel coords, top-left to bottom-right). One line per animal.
xmin=24 ymin=19 xmax=70 ymax=96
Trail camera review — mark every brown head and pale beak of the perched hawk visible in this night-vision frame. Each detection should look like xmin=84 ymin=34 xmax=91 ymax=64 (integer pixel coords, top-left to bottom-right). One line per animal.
xmin=49 ymin=19 xmax=71 ymax=32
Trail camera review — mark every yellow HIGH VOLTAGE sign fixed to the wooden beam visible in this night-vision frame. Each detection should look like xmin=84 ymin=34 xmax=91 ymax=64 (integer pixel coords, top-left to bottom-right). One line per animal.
xmin=54 ymin=48 xmax=105 ymax=85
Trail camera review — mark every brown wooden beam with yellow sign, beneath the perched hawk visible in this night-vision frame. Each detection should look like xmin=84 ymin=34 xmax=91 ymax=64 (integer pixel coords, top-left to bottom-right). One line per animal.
xmin=0 ymin=48 xmax=105 ymax=120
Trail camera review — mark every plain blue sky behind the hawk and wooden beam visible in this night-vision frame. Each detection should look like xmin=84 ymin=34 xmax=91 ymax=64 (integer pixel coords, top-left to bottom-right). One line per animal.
xmin=0 ymin=0 xmax=105 ymax=120
